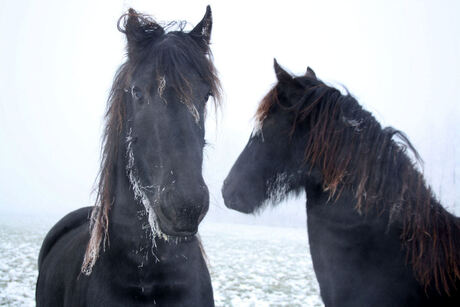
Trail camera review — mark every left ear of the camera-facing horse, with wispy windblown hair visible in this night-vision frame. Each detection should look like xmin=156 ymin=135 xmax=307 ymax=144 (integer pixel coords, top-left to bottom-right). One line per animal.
xmin=118 ymin=8 xmax=164 ymax=56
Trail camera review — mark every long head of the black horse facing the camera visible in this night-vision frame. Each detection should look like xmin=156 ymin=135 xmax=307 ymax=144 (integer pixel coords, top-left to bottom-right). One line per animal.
xmin=119 ymin=6 xmax=218 ymax=236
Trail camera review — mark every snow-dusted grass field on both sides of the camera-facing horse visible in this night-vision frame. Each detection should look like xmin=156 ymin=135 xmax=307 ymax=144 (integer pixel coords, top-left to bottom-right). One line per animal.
xmin=0 ymin=217 xmax=323 ymax=307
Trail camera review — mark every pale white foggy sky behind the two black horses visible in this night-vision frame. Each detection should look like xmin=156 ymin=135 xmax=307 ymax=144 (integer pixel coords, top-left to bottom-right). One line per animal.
xmin=0 ymin=0 xmax=460 ymax=225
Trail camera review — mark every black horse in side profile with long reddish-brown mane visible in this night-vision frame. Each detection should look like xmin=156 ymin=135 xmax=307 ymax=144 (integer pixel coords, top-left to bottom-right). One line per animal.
xmin=222 ymin=61 xmax=460 ymax=307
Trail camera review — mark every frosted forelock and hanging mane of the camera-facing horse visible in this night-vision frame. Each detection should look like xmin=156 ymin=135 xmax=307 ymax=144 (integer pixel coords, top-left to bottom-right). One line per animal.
xmin=81 ymin=9 xmax=221 ymax=275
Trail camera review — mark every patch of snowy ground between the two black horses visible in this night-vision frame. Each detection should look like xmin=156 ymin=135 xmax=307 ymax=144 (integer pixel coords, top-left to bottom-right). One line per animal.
xmin=201 ymin=224 xmax=322 ymax=307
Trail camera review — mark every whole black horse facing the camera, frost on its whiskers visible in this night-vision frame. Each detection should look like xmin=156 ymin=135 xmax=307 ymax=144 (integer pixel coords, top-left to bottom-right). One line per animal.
xmin=36 ymin=6 xmax=220 ymax=307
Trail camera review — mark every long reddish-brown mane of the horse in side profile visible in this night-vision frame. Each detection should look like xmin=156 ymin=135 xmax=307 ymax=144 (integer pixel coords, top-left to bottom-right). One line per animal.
xmin=255 ymin=77 xmax=460 ymax=294
